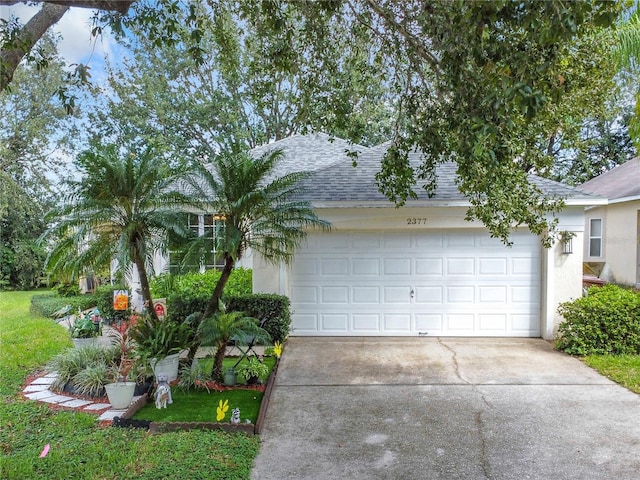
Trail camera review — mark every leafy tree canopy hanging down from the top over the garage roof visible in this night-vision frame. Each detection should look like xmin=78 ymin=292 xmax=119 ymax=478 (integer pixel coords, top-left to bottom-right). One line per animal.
xmin=1 ymin=0 xmax=623 ymax=241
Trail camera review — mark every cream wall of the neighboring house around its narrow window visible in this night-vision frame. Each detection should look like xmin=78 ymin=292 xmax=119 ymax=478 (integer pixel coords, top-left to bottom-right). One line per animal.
xmin=584 ymin=199 xmax=640 ymax=285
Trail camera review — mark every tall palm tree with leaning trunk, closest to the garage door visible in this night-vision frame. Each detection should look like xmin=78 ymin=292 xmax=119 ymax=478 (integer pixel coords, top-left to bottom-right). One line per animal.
xmin=194 ymin=150 xmax=330 ymax=318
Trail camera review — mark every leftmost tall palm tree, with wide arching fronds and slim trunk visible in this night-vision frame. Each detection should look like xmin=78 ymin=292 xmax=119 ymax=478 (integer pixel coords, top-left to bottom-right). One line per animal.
xmin=42 ymin=143 xmax=191 ymax=317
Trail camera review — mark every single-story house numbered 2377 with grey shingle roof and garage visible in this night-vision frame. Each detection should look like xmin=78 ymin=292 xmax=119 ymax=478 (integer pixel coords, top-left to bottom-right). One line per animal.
xmin=253 ymin=134 xmax=606 ymax=339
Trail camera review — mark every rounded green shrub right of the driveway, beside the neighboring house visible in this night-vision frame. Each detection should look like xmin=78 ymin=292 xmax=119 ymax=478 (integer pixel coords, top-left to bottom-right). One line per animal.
xmin=556 ymin=285 xmax=640 ymax=355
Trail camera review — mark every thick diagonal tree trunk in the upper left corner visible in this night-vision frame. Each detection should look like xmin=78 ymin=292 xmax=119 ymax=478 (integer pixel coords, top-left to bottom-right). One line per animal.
xmin=0 ymin=3 xmax=69 ymax=92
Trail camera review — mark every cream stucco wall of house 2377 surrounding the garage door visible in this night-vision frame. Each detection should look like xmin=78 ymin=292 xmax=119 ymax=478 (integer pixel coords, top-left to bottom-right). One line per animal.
xmin=253 ymin=206 xmax=585 ymax=339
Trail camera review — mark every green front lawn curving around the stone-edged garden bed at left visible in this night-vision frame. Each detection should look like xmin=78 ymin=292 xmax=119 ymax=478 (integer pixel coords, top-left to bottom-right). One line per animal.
xmin=0 ymin=292 xmax=259 ymax=480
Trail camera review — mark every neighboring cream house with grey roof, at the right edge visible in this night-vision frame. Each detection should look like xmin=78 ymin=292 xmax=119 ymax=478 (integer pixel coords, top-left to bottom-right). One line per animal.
xmin=578 ymin=157 xmax=640 ymax=287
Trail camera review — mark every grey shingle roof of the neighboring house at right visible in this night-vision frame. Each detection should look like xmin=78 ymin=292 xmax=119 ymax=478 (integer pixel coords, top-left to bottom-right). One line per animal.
xmin=578 ymin=157 xmax=640 ymax=200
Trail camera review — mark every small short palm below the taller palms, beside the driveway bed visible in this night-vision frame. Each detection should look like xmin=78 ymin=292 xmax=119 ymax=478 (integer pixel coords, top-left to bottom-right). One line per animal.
xmin=198 ymin=308 xmax=271 ymax=379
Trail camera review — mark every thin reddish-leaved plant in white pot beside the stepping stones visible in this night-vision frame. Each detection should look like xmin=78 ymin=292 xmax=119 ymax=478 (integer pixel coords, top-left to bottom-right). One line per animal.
xmin=104 ymin=322 xmax=136 ymax=410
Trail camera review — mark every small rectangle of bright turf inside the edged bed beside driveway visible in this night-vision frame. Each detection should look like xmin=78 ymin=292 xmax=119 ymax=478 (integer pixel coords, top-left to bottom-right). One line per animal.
xmin=133 ymin=388 xmax=264 ymax=424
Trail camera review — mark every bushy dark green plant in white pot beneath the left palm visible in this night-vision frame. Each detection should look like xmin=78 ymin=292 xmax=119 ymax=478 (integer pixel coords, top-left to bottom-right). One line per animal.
xmin=131 ymin=316 xmax=191 ymax=382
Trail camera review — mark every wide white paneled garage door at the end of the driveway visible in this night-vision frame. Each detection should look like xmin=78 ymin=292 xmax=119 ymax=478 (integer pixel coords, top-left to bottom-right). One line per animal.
xmin=289 ymin=230 xmax=541 ymax=337
